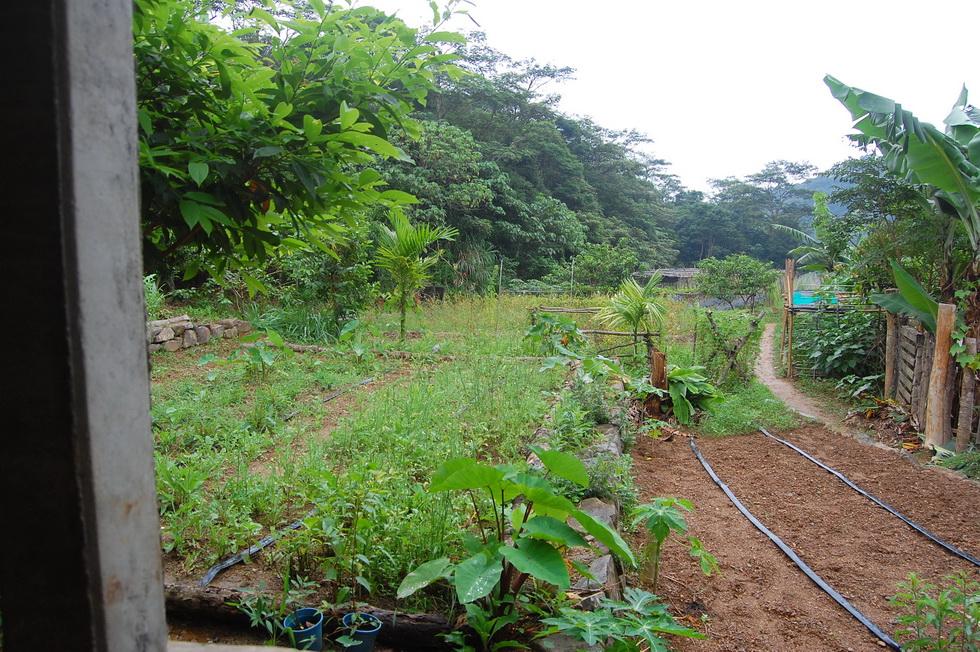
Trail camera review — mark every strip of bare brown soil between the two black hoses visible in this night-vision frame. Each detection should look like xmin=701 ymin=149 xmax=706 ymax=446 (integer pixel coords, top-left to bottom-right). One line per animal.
xmin=676 ymin=433 xmax=980 ymax=648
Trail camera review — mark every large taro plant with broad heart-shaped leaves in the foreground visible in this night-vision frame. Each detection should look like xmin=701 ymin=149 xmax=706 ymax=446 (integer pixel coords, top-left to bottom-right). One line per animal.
xmin=397 ymin=447 xmax=636 ymax=650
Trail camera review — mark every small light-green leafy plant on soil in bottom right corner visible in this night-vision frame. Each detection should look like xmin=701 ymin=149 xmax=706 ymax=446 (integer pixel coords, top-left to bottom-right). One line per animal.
xmin=889 ymin=573 xmax=980 ymax=651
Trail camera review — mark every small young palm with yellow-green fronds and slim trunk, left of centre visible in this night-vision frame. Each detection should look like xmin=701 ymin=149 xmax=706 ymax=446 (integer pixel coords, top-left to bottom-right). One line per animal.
xmin=376 ymin=213 xmax=459 ymax=341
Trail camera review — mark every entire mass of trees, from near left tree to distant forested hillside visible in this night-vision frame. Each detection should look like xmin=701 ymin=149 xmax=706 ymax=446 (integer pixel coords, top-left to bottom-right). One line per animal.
xmin=135 ymin=0 xmax=836 ymax=303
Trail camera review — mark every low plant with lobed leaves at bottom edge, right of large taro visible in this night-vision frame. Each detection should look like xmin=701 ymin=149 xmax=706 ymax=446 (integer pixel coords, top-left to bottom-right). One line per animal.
xmin=540 ymin=587 xmax=705 ymax=652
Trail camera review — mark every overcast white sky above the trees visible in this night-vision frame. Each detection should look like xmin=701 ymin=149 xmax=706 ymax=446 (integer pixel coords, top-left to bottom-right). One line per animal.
xmin=358 ymin=0 xmax=980 ymax=191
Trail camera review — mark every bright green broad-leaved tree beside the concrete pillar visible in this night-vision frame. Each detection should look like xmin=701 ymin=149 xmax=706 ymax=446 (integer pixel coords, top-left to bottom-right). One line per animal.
xmin=134 ymin=0 xmax=463 ymax=289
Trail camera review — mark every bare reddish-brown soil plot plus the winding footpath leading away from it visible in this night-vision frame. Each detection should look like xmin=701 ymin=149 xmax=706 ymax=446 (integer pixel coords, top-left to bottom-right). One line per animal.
xmin=634 ymin=329 xmax=980 ymax=651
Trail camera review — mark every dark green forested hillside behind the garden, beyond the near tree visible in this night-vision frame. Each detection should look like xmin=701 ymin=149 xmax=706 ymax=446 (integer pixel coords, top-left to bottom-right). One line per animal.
xmin=376 ymin=34 xmax=828 ymax=279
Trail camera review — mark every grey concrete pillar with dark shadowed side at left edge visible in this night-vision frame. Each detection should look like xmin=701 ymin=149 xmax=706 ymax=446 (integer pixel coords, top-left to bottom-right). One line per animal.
xmin=0 ymin=0 xmax=166 ymax=652
